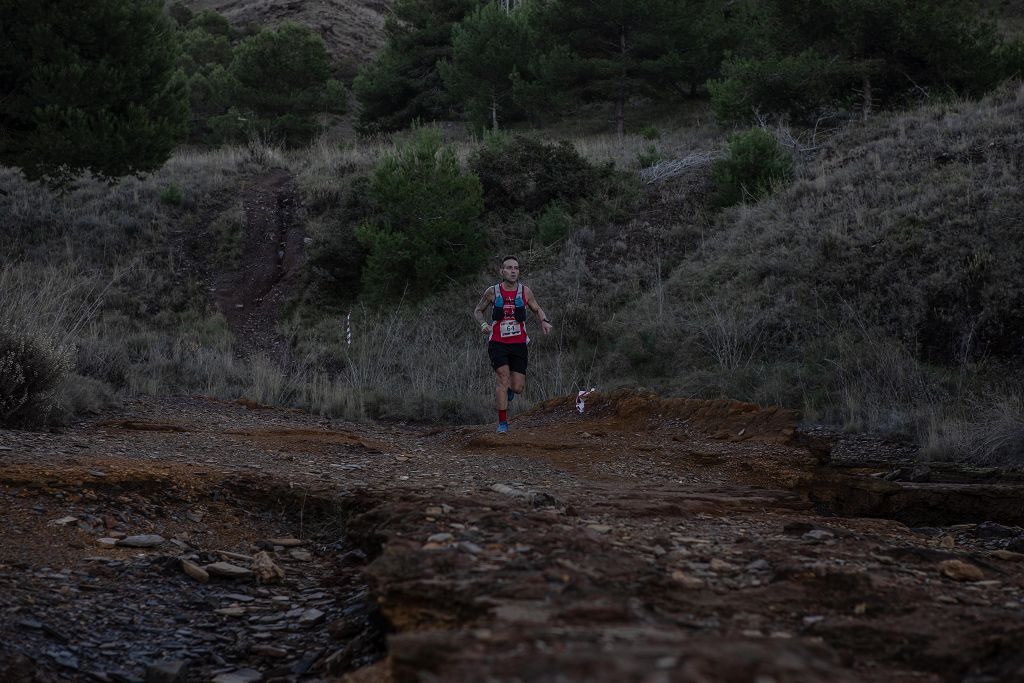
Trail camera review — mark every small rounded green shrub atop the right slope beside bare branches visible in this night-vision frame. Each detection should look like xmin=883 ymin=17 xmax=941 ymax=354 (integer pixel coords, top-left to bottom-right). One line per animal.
xmin=712 ymin=128 xmax=793 ymax=206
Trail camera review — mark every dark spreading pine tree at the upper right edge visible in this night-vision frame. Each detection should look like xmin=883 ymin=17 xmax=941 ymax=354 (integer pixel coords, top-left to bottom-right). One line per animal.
xmin=709 ymin=0 xmax=1010 ymax=122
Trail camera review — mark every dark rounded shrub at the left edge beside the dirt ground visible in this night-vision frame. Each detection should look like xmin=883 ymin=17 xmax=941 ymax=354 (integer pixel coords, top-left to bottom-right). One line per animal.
xmin=0 ymin=330 xmax=72 ymax=426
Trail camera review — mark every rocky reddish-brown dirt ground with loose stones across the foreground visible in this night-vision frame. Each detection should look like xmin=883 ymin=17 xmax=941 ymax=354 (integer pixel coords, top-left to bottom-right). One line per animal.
xmin=0 ymin=392 xmax=1024 ymax=683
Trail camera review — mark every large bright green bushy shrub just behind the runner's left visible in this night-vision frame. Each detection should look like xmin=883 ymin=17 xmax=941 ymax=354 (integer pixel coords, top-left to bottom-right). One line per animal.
xmin=355 ymin=128 xmax=485 ymax=300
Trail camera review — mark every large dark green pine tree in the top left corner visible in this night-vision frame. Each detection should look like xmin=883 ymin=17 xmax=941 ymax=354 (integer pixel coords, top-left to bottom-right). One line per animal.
xmin=0 ymin=0 xmax=188 ymax=185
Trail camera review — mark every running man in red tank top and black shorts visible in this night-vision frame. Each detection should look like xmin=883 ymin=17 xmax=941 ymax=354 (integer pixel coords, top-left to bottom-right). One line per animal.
xmin=473 ymin=256 xmax=551 ymax=434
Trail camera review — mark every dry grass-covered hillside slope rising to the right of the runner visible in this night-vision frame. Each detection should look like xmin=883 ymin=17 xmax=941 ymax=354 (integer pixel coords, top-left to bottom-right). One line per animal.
xmin=593 ymin=83 xmax=1024 ymax=433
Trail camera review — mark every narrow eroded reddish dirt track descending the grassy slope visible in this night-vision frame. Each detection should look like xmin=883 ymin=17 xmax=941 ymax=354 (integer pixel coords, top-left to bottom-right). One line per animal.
xmin=215 ymin=169 xmax=305 ymax=361
